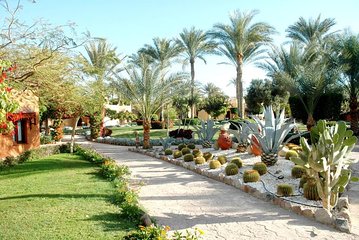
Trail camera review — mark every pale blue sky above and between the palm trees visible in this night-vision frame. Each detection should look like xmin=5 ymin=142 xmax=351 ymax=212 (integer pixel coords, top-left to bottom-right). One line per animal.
xmin=12 ymin=0 xmax=359 ymax=96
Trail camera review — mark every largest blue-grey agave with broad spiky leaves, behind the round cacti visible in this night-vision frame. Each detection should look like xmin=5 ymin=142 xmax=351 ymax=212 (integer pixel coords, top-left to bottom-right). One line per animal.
xmin=245 ymin=106 xmax=295 ymax=166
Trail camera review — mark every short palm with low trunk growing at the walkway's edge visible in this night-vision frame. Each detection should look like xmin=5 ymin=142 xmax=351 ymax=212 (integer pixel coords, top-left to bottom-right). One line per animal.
xmin=119 ymin=58 xmax=186 ymax=148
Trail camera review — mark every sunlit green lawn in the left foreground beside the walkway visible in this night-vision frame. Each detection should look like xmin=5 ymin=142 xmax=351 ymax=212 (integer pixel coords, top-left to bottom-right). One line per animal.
xmin=0 ymin=154 xmax=135 ymax=240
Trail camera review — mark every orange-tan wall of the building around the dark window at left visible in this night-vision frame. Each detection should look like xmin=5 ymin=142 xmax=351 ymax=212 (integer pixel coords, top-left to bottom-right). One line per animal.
xmin=0 ymin=90 xmax=40 ymax=158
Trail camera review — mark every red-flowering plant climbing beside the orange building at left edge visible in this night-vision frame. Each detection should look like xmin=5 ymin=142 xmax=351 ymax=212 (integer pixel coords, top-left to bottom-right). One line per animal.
xmin=0 ymin=60 xmax=18 ymax=134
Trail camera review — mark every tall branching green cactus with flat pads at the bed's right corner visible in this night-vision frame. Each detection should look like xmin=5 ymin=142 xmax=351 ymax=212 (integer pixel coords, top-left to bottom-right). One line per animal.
xmin=290 ymin=120 xmax=358 ymax=210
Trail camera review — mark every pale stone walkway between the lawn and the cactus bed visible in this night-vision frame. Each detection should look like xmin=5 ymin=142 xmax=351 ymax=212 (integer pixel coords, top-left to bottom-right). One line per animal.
xmin=78 ymin=139 xmax=359 ymax=240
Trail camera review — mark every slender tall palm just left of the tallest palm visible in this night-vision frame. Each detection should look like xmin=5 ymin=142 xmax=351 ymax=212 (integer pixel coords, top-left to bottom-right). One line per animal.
xmin=176 ymin=27 xmax=217 ymax=118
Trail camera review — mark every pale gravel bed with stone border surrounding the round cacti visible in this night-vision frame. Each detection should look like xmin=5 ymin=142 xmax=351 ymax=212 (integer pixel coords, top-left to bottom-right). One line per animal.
xmin=129 ymin=146 xmax=351 ymax=232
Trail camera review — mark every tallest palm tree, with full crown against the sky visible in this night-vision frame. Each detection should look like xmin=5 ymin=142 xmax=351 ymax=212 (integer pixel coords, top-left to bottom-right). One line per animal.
xmin=211 ymin=10 xmax=275 ymax=117
